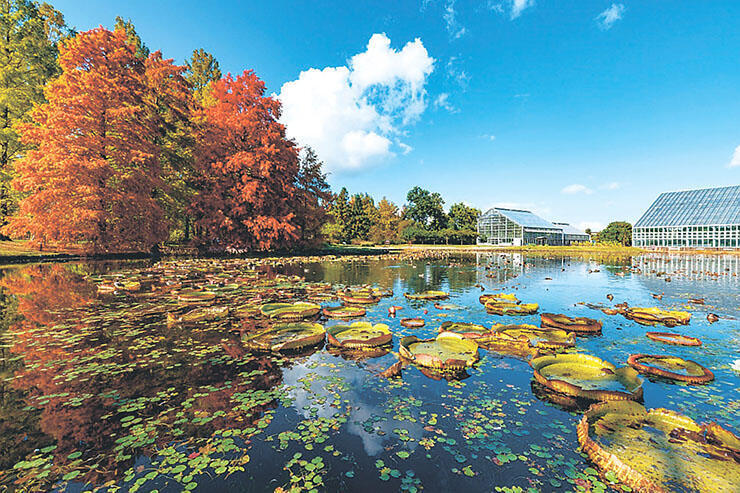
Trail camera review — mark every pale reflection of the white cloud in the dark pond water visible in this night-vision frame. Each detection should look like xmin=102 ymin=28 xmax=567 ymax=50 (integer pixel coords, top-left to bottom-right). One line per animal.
xmin=283 ymin=358 xmax=424 ymax=456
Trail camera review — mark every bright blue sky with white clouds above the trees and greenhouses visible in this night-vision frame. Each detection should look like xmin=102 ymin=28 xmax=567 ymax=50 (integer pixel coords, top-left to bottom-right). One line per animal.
xmin=52 ymin=0 xmax=740 ymax=229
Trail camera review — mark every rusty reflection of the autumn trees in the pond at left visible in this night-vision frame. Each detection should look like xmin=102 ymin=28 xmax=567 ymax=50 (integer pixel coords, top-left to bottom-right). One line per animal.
xmin=0 ymin=265 xmax=282 ymax=486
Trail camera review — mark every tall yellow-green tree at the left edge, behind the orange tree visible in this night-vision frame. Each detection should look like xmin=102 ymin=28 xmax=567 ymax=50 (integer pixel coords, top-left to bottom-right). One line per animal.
xmin=0 ymin=0 xmax=71 ymax=226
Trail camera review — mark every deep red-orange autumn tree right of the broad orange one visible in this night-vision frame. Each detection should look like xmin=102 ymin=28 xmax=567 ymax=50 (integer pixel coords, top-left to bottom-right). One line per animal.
xmin=193 ymin=70 xmax=299 ymax=250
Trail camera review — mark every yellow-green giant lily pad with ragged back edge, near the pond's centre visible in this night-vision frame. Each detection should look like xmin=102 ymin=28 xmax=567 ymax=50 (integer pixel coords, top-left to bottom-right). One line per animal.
xmin=399 ymin=332 xmax=478 ymax=370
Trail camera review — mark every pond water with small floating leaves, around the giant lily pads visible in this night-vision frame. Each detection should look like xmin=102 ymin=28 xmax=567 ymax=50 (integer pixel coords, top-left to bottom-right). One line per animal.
xmin=0 ymin=253 xmax=740 ymax=492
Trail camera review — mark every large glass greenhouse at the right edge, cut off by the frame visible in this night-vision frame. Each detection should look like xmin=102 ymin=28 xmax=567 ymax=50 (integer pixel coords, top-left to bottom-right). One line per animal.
xmin=632 ymin=185 xmax=740 ymax=248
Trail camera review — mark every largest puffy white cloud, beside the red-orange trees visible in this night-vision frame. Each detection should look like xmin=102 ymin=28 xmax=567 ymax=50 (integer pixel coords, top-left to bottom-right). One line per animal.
xmin=278 ymin=34 xmax=434 ymax=171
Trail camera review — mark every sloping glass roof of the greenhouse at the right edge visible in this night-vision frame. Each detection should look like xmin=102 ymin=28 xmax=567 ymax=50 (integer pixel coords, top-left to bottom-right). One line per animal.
xmin=635 ymin=185 xmax=740 ymax=228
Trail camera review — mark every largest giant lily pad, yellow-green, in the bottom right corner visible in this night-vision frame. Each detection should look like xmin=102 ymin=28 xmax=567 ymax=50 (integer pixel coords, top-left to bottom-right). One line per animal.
xmin=577 ymin=401 xmax=740 ymax=493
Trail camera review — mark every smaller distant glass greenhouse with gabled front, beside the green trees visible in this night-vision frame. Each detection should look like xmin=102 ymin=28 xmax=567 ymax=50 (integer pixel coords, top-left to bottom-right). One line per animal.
xmin=478 ymin=207 xmax=591 ymax=246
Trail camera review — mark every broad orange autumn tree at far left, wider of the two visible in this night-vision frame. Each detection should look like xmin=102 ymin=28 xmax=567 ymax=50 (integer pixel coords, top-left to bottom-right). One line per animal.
xmin=5 ymin=27 xmax=184 ymax=252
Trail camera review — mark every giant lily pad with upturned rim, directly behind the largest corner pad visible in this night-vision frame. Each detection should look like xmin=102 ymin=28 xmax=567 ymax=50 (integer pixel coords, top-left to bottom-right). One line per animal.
xmin=529 ymin=354 xmax=642 ymax=401
